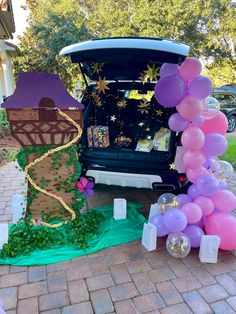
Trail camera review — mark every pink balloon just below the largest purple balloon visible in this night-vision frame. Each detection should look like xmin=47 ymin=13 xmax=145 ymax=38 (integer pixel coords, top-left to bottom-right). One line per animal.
xmin=176 ymin=96 xmax=203 ymax=121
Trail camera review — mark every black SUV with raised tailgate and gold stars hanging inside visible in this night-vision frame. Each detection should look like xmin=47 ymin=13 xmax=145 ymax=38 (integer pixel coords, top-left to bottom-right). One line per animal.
xmin=60 ymin=38 xmax=189 ymax=191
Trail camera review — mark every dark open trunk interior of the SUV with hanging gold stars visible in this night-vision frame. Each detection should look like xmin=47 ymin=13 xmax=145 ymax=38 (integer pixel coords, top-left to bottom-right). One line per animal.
xmin=81 ymin=82 xmax=176 ymax=173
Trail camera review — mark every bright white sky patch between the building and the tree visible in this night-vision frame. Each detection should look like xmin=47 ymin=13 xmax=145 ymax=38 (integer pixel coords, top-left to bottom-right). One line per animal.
xmin=9 ymin=0 xmax=28 ymax=45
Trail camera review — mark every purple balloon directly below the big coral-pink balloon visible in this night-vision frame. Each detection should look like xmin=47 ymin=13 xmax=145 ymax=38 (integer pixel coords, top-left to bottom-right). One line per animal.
xmin=202 ymin=133 xmax=228 ymax=158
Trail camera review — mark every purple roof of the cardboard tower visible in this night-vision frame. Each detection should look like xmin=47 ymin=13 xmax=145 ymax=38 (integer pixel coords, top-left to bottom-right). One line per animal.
xmin=2 ymin=73 xmax=84 ymax=109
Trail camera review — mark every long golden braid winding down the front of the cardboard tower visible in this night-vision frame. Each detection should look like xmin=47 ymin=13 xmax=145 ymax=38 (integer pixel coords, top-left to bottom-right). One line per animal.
xmin=24 ymin=109 xmax=82 ymax=228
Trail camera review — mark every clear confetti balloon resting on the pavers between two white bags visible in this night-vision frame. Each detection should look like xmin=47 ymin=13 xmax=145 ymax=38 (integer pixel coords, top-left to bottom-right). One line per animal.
xmin=166 ymin=232 xmax=191 ymax=258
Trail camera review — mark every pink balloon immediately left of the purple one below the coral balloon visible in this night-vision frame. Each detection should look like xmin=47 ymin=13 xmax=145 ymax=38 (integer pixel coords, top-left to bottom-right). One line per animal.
xmin=181 ymin=126 xmax=205 ymax=150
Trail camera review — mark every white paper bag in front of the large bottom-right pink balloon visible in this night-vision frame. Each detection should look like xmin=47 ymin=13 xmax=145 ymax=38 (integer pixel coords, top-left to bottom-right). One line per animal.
xmin=199 ymin=235 xmax=221 ymax=263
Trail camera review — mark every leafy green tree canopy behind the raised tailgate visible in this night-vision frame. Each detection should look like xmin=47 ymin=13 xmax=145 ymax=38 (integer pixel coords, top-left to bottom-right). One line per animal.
xmin=15 ymin=0 xmax=236 ymax=86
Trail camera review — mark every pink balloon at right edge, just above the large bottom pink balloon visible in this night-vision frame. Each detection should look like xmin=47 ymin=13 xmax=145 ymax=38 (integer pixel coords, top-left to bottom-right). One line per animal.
xmin=211 ymin=190 xmax=236 ymax=212
